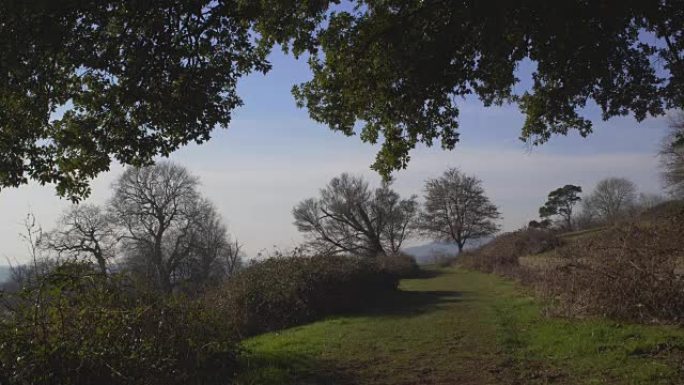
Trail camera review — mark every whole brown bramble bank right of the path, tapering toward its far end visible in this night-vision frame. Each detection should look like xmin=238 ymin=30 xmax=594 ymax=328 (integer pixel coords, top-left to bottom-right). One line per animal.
xmin=460 ymin=212 xmax=684 ymax=324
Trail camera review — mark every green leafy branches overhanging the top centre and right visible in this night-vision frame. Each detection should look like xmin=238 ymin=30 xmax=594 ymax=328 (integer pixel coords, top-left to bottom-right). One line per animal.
xmin=295 ymin=0 xmax=684 ymax=176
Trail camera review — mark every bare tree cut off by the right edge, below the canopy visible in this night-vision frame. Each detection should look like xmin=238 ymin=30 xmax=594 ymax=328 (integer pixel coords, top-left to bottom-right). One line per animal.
xmin=660 ymin=112 xmax=684 ymax=199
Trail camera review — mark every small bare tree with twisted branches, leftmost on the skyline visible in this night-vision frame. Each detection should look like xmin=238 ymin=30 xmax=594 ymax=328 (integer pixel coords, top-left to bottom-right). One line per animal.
xmin=39 ymin=204 xmax=117 ymax=274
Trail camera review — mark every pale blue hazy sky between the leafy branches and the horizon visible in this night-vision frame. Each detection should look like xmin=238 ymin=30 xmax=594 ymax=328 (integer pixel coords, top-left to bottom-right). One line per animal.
xmin=0 ymin=51 xmax=668 ymax=264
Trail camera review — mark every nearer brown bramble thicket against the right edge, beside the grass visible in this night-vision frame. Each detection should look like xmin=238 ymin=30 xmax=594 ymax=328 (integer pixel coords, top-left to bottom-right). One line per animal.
xmin=537 ymin=219 xmax=684 ymax=323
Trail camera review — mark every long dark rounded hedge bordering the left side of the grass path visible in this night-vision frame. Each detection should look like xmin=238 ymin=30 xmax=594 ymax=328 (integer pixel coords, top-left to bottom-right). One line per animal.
xmin=216 ymin=256 xmax=403 ymax=335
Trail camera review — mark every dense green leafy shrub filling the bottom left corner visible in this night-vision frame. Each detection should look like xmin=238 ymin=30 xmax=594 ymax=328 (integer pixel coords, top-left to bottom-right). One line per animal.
xmin=0 ymin=264 xmax=237 ymax=385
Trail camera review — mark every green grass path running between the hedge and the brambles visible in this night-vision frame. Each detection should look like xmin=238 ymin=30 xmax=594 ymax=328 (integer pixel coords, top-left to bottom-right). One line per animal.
xmin=238 ymin=269 xmax=684 ymax=385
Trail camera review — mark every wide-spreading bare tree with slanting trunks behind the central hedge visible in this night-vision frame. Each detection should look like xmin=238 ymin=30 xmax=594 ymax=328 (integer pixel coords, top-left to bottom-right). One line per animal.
xmin=293 ymin=173 xmax=418 ymax=257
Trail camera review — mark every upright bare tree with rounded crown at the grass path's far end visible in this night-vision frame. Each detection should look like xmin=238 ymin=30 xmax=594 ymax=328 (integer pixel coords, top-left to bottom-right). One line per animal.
xmin=418 ymin=168 xmax=501 ymax=252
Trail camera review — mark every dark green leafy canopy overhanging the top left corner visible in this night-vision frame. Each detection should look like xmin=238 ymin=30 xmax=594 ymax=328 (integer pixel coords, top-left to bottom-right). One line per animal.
xmin=0 ymin=0 xmax=327 ymax=200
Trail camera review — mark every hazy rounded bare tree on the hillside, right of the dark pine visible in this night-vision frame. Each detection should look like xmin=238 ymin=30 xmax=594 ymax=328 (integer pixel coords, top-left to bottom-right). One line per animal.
xmin=583 ymin=178 xmax=637 ymax=222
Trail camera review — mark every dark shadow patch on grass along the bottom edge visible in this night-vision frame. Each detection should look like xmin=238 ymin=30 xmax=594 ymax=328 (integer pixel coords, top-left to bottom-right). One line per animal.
xmin=234 ymin=351 xmax=358 ymax=385
